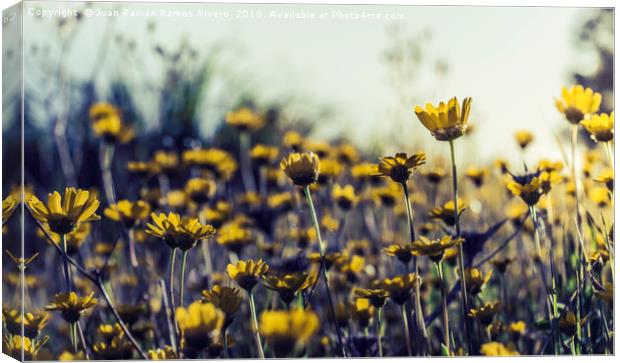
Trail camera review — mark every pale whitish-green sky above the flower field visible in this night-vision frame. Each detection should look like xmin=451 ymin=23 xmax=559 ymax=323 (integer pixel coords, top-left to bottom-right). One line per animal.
xmin=20 ymin=3 xmax=596 ymax=165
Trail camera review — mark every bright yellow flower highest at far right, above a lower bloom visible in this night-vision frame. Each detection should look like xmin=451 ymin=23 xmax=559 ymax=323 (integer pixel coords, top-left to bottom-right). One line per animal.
xmin=555 ymin=85 xmax=602 ymax=124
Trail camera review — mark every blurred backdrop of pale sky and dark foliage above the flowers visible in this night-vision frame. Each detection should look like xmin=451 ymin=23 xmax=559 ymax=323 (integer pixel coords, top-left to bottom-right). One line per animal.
xmin=3 ymin=2 xmax=613 ymax=189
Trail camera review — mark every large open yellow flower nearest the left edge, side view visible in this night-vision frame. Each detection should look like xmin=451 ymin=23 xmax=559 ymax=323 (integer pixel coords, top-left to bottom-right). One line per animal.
xmin=27 ymin=188 xmax=100 ymax=234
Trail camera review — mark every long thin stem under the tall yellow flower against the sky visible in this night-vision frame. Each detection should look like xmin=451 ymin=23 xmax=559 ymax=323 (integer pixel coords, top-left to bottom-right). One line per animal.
xmin=450 ymin=140 xmax=473 ymax=353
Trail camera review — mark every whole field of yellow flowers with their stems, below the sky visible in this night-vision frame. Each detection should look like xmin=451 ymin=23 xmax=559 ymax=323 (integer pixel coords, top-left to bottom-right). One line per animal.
xmin=2 ymin=86 xmax=614 ymax=360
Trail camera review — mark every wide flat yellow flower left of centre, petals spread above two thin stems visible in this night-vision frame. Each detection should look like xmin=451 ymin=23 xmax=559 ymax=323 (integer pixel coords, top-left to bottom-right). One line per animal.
xmin=146 ymin=212 xmax=215 ymax=251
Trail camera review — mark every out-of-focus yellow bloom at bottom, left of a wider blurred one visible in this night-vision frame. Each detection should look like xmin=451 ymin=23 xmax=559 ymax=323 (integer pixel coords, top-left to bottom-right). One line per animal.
xmin=176 ymin=301 xmax=224 ymax=351
